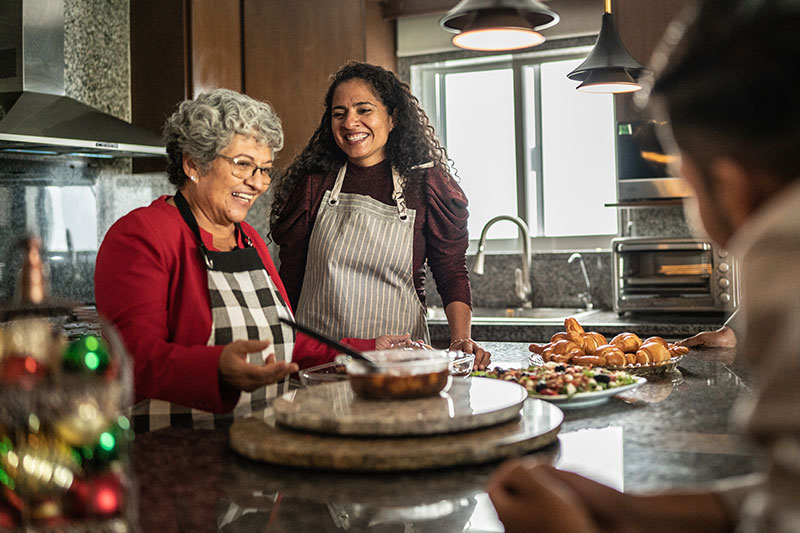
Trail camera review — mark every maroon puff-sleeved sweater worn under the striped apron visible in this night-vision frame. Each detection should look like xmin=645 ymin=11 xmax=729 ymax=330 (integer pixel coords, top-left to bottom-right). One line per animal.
xmin=272 ymin=160 xmax=472 ymax=308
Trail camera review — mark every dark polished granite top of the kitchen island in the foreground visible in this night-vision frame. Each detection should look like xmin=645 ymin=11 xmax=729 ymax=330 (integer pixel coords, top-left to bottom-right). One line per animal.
xmin=133 ymin=342 xmax=759 ymax=532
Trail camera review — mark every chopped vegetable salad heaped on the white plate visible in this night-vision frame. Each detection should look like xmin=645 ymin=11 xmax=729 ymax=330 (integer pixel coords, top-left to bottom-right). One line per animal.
xmin=472 ymin=362 xmax=636 ymax=397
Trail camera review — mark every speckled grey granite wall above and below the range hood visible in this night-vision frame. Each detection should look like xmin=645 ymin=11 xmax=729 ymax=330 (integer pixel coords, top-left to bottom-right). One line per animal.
xmin=0 ymin=0 xmax=170 ymax=302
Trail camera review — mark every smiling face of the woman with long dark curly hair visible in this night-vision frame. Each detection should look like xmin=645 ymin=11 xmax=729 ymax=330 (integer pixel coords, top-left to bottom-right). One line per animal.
xmin=331 ymin=79 xmax=394 ymax=167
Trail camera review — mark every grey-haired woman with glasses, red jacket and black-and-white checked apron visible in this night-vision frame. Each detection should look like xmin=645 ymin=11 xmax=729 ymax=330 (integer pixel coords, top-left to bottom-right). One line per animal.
xmin=95 ymin=89 xmax=404 ymax=431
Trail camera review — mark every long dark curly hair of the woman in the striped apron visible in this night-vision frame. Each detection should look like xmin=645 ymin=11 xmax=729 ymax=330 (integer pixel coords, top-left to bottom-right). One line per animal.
xmin=270 ymin=61 xmax=450 ymax=225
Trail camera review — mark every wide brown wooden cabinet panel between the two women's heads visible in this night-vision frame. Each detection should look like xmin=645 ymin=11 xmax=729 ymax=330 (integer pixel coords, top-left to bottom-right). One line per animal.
xmin=243 ymin=0 xmax=365 ymax=167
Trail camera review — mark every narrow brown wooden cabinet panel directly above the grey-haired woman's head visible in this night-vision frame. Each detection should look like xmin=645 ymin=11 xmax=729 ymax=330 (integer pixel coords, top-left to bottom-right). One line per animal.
xmin=191 ymin=0 xmax=242 ymax=97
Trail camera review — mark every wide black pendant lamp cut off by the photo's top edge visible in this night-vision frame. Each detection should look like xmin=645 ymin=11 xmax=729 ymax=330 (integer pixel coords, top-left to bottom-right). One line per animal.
xmin=439 ymin=0 xmax=558 ymax=51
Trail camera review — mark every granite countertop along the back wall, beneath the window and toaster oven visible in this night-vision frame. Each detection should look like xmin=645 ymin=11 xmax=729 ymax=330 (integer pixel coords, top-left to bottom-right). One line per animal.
xmin=428 ymin=309 xmax=726 ymax=346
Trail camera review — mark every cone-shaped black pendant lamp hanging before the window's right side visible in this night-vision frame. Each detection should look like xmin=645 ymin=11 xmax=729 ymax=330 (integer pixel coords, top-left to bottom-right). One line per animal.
xmin=567 ymin=0 xmax=651 ymax=94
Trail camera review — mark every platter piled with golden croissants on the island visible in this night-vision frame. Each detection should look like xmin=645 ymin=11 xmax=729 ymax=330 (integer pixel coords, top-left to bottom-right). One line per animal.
xmin=529 ymin=317 xmax=689 ymax=375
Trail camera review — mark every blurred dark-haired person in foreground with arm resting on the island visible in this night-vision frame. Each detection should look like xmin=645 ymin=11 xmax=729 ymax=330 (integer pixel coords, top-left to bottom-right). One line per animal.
xmin=488 ymin=0 xmax=800 ymax=533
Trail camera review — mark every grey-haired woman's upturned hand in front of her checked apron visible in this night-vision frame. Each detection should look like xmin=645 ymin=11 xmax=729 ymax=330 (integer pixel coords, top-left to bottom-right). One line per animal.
xmin=219 ymin=340 xmax=298 ymax=392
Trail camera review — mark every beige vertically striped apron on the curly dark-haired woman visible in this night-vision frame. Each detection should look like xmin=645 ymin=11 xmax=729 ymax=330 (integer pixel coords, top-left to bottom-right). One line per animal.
xmin=297 ymin=163 xmax=430 ymax=343
